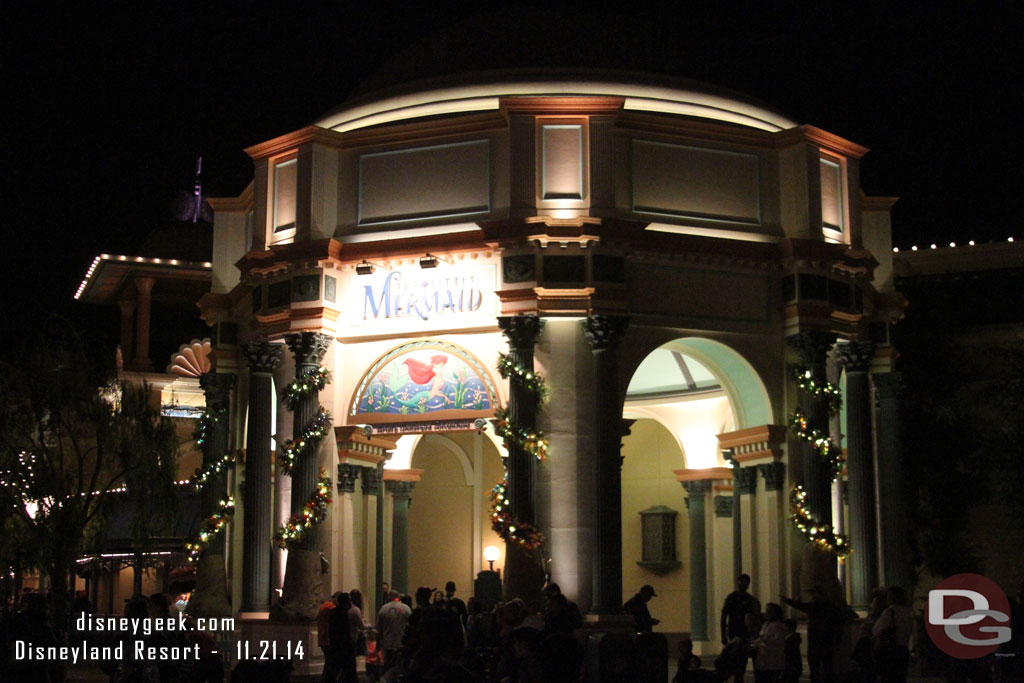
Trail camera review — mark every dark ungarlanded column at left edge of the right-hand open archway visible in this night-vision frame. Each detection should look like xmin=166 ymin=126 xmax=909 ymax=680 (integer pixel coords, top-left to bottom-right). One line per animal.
xmin=583 ymin=315 xmax=629 ymax=614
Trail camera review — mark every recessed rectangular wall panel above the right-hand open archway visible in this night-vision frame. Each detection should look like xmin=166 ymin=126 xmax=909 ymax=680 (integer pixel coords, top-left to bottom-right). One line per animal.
xmin=632 ymin=140 xmax=761 ymax=225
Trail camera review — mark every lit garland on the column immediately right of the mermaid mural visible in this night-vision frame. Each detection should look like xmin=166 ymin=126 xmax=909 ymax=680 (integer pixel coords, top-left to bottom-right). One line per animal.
xmin=489 ymin=353 xmax=548 ymax=550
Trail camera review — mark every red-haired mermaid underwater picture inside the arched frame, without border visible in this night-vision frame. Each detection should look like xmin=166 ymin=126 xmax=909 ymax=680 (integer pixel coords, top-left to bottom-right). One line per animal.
xmin=357 ymin=353 xmax=490 ymax=415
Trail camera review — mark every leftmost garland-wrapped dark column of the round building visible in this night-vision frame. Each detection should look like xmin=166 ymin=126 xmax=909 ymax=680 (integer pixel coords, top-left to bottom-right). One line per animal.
xmin=188 ymin=373 xmax=234 ymax=616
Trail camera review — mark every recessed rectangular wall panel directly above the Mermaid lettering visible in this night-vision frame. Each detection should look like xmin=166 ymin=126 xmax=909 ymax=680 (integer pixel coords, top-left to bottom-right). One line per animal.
xmin=359 ymin=140 xmax=490 ymax=225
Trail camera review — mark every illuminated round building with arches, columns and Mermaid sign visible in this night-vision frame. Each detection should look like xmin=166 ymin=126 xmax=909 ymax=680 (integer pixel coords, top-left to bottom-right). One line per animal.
xmin=81 ymin=75 xmax=906 ymax=651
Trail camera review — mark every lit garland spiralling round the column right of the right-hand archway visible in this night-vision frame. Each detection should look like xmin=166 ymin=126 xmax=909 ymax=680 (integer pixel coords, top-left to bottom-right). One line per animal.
xmin=790 ymin=366 xmax=852 ymax=559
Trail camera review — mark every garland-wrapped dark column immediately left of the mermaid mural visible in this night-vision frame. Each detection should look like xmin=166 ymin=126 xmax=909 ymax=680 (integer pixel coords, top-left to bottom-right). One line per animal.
xmin=271 ymin=332 xmax=333 ymax=621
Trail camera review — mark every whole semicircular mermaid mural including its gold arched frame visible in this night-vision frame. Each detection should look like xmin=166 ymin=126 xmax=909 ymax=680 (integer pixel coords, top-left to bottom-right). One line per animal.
xmin=349 ymin=340 xmax=497 ymax=424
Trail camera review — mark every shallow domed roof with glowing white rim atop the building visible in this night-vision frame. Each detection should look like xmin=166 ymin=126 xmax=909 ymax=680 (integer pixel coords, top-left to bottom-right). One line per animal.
xmin=316 ymin=69 xmax=797 ymax=131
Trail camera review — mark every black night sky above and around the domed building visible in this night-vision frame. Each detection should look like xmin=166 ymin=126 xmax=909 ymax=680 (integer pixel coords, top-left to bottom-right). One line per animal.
xmin=3 ymin=2 xmax=1024 ymax=335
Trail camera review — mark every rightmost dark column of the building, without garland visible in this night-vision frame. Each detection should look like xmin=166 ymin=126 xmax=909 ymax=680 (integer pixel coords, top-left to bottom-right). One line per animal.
xmin=871 ymin=373 xmax=913 ymax=590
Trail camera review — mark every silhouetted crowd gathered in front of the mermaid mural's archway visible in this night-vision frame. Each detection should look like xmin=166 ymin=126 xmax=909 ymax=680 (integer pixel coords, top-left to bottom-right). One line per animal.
xmin=316 ymin=582 xmax=583 ymax=683
